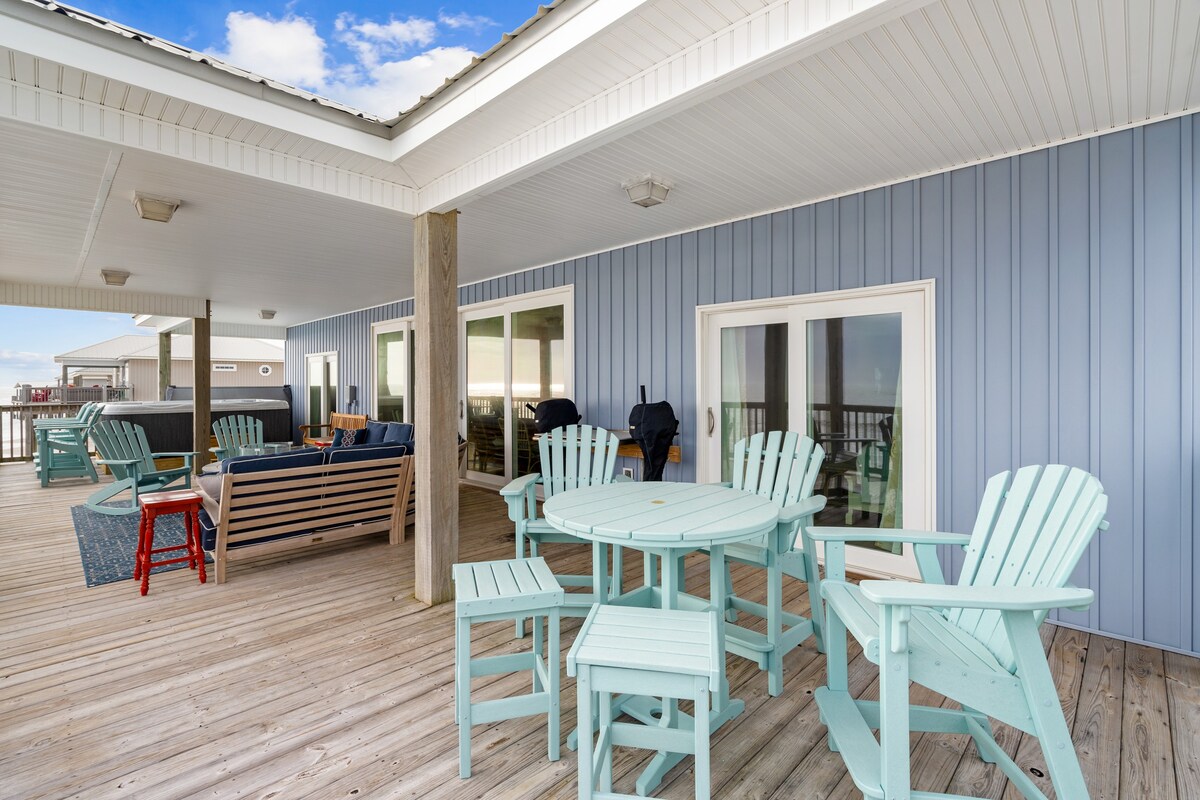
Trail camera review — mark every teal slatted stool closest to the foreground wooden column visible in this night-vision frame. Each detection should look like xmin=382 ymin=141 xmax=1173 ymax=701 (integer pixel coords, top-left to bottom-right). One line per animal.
xmin=454 ymin=558 xmax=564 ymax=777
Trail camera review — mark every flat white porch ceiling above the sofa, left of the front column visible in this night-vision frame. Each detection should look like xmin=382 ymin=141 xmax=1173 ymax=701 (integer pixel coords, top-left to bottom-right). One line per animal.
xmin=0 ymin=120 xmax=413 ymax=325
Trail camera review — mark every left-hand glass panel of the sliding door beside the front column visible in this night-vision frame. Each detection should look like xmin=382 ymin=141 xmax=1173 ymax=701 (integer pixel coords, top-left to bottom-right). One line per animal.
xmin=464 ymin=315 xmax=508 ymax=477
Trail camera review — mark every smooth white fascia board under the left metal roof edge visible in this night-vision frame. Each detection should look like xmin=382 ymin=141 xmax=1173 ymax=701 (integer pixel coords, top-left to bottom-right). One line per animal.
xmin=0 ymin=11 xmax=391 ymax=161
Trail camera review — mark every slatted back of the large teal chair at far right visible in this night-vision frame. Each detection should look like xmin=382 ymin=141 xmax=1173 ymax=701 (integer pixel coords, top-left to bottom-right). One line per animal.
xmin=947 ymin=464 xmax=1109 ymax=670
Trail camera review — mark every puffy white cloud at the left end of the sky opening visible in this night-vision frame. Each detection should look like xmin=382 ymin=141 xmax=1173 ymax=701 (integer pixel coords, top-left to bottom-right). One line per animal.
xmin=218 ymin=11 xmax=328 ymax=88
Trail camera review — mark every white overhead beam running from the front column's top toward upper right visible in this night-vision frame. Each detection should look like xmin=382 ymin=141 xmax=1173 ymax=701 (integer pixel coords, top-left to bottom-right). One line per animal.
xmin=418 ymin=0 xmax=936 ymax=213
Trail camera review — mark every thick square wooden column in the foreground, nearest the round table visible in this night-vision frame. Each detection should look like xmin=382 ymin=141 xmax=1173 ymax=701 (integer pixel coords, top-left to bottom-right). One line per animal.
xmin=413 ymin=211 xmax=458 ymax=606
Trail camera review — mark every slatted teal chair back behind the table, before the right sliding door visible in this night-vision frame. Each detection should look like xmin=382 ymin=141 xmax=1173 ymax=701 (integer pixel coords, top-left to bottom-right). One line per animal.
xmin=732 ymin=431 xmax=824 ymax=515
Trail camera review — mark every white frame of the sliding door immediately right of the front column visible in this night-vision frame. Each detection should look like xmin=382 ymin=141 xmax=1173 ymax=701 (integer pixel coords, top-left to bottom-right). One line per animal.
xmin=458 ymin=285 xmax=575 ymax=486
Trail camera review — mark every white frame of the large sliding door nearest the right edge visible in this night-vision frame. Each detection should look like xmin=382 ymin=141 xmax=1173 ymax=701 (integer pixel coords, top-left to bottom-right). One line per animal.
xmin=696 ymin=279 xmax=937 ymax=577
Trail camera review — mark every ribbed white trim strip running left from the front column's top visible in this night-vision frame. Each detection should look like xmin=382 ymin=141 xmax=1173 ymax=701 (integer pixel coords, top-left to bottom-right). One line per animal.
xmin=0 ymin=80 xmax=418 ymax=216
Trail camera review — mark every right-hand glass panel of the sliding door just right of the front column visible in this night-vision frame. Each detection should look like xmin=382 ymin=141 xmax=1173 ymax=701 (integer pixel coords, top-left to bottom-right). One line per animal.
xmin=509 ymin=306 xmax=566 ymax=477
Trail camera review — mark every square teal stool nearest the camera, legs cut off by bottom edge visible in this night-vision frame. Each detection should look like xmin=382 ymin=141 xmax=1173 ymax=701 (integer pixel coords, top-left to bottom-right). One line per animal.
xmin=566 ymin=606 xmax=722 ymax=800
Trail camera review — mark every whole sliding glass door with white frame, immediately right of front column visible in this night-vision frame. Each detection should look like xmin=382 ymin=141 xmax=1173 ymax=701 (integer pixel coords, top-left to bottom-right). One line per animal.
xmin=461 ymin=290 xmax=572 ymax=485
